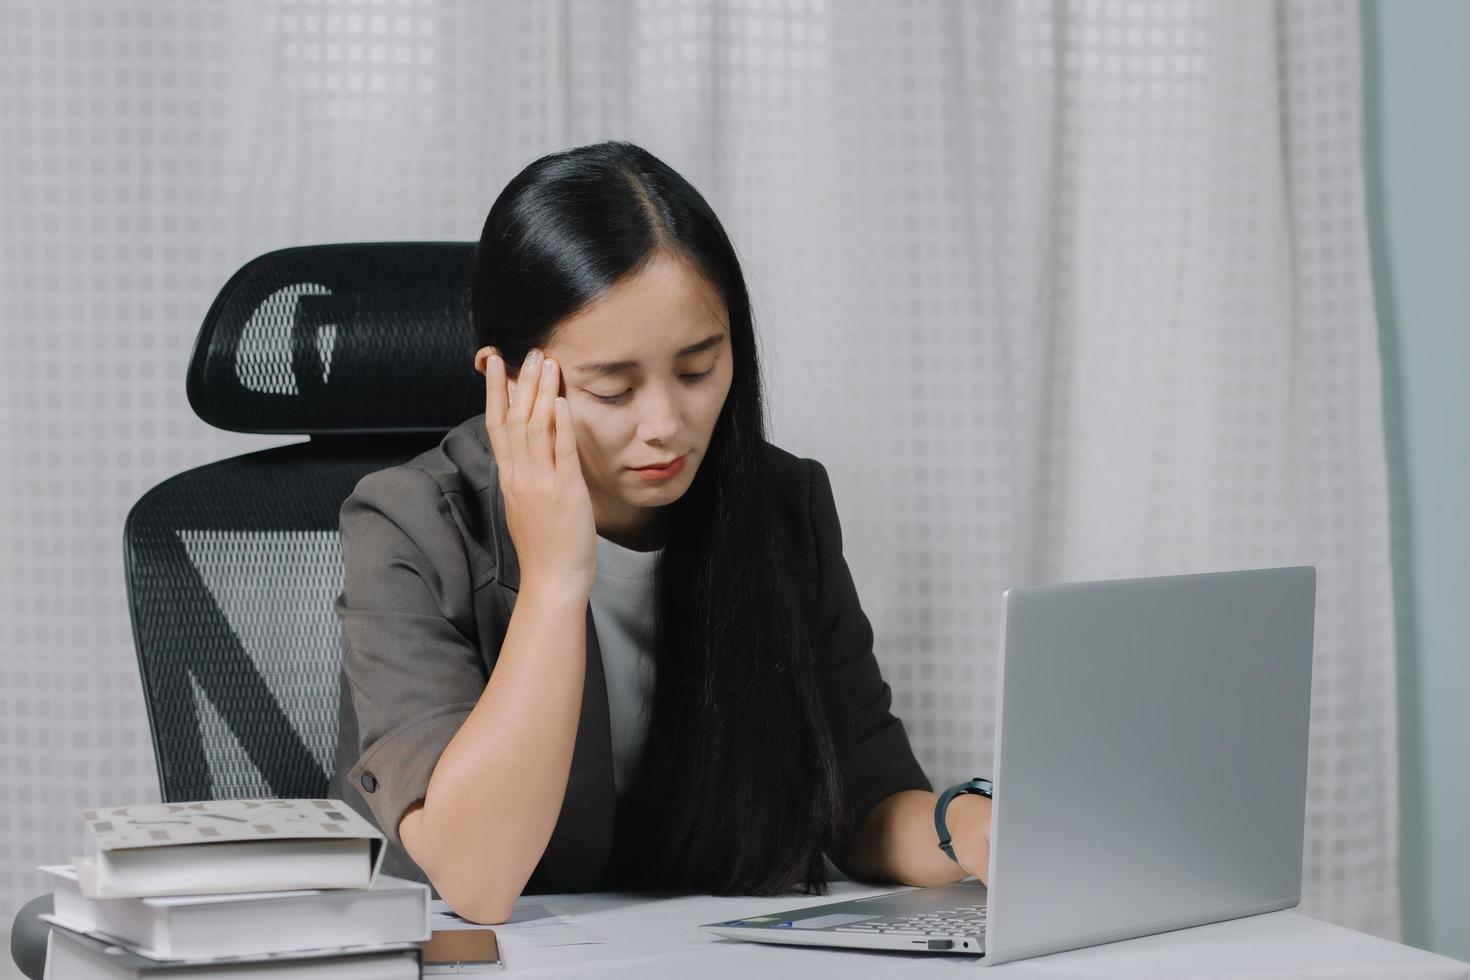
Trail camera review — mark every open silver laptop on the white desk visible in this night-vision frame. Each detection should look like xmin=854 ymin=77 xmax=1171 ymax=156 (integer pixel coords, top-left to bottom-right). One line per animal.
xmin=701 ymin=566 xmax=1317 ymax=964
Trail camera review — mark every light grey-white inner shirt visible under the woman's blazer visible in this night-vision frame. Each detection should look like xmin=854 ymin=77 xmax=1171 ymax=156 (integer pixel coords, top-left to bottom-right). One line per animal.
xmin=589 ymin=535 xmax=663 ymax=796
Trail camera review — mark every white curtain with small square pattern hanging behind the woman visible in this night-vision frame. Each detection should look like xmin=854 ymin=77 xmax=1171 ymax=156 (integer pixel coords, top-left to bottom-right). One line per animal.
xmin=0 ymin=0 xmax=1399 ymax=967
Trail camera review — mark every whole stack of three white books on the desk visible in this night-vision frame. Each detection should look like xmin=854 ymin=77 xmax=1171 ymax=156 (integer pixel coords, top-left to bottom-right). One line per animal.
xmin=41 ymin=799 xmax=431 ymax=980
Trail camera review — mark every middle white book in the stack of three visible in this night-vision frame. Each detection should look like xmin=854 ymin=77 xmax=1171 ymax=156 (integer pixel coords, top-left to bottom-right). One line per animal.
xmin=41 ymin=864 xmax=431 ymax=959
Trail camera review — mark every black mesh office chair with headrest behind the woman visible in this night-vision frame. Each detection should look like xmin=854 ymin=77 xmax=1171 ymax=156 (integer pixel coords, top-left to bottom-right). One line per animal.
xmin=10 ymin=242 xmax=485 ymax=979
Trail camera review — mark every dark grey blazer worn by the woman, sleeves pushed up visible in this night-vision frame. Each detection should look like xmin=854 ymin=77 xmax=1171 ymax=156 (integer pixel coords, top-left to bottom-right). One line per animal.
xmin=329 ymin=414 xmax=932 ymax=893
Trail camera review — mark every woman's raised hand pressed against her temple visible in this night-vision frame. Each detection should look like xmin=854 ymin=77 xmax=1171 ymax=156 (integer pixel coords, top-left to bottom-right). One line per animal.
xmin=484 ymin=348 xmax=597 ymax=595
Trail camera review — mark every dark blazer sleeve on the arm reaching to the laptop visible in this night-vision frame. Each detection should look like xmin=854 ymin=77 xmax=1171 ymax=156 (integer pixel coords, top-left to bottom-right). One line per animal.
xmin=809 ymin=460 xmax=933 ymax=830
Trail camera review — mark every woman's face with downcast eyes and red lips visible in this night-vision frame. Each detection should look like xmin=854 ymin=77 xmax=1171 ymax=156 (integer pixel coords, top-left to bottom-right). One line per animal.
xmin=485 ymin=256 xmax=734 ymax=547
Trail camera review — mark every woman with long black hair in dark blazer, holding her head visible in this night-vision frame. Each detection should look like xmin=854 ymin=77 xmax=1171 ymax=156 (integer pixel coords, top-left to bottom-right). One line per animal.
xmin=334 ymin=143 xmax=989 ymax=923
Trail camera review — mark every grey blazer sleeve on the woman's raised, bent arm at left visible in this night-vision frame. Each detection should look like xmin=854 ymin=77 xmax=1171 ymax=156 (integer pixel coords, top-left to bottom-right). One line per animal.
xmin=334 ymin=466 xmax=487 ymax=846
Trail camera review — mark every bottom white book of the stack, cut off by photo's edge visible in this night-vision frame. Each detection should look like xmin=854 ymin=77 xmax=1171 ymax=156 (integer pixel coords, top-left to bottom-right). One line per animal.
xmin=44 ymin=929 xmax=422 ymax=980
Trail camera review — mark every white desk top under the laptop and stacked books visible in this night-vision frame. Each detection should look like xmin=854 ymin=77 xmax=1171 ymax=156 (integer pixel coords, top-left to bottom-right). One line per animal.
xmin=504 ymin=882 xmax=1470 ymax=980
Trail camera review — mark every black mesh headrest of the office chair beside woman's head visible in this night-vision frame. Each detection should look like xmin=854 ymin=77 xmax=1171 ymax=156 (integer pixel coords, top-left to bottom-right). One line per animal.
xmin=187 ymin=241 xmax=485 ymax=435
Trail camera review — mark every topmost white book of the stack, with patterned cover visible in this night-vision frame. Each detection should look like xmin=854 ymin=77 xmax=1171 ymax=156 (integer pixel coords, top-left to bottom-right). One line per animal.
xmin=74 ymin=799 xmax=385 ymax=898
